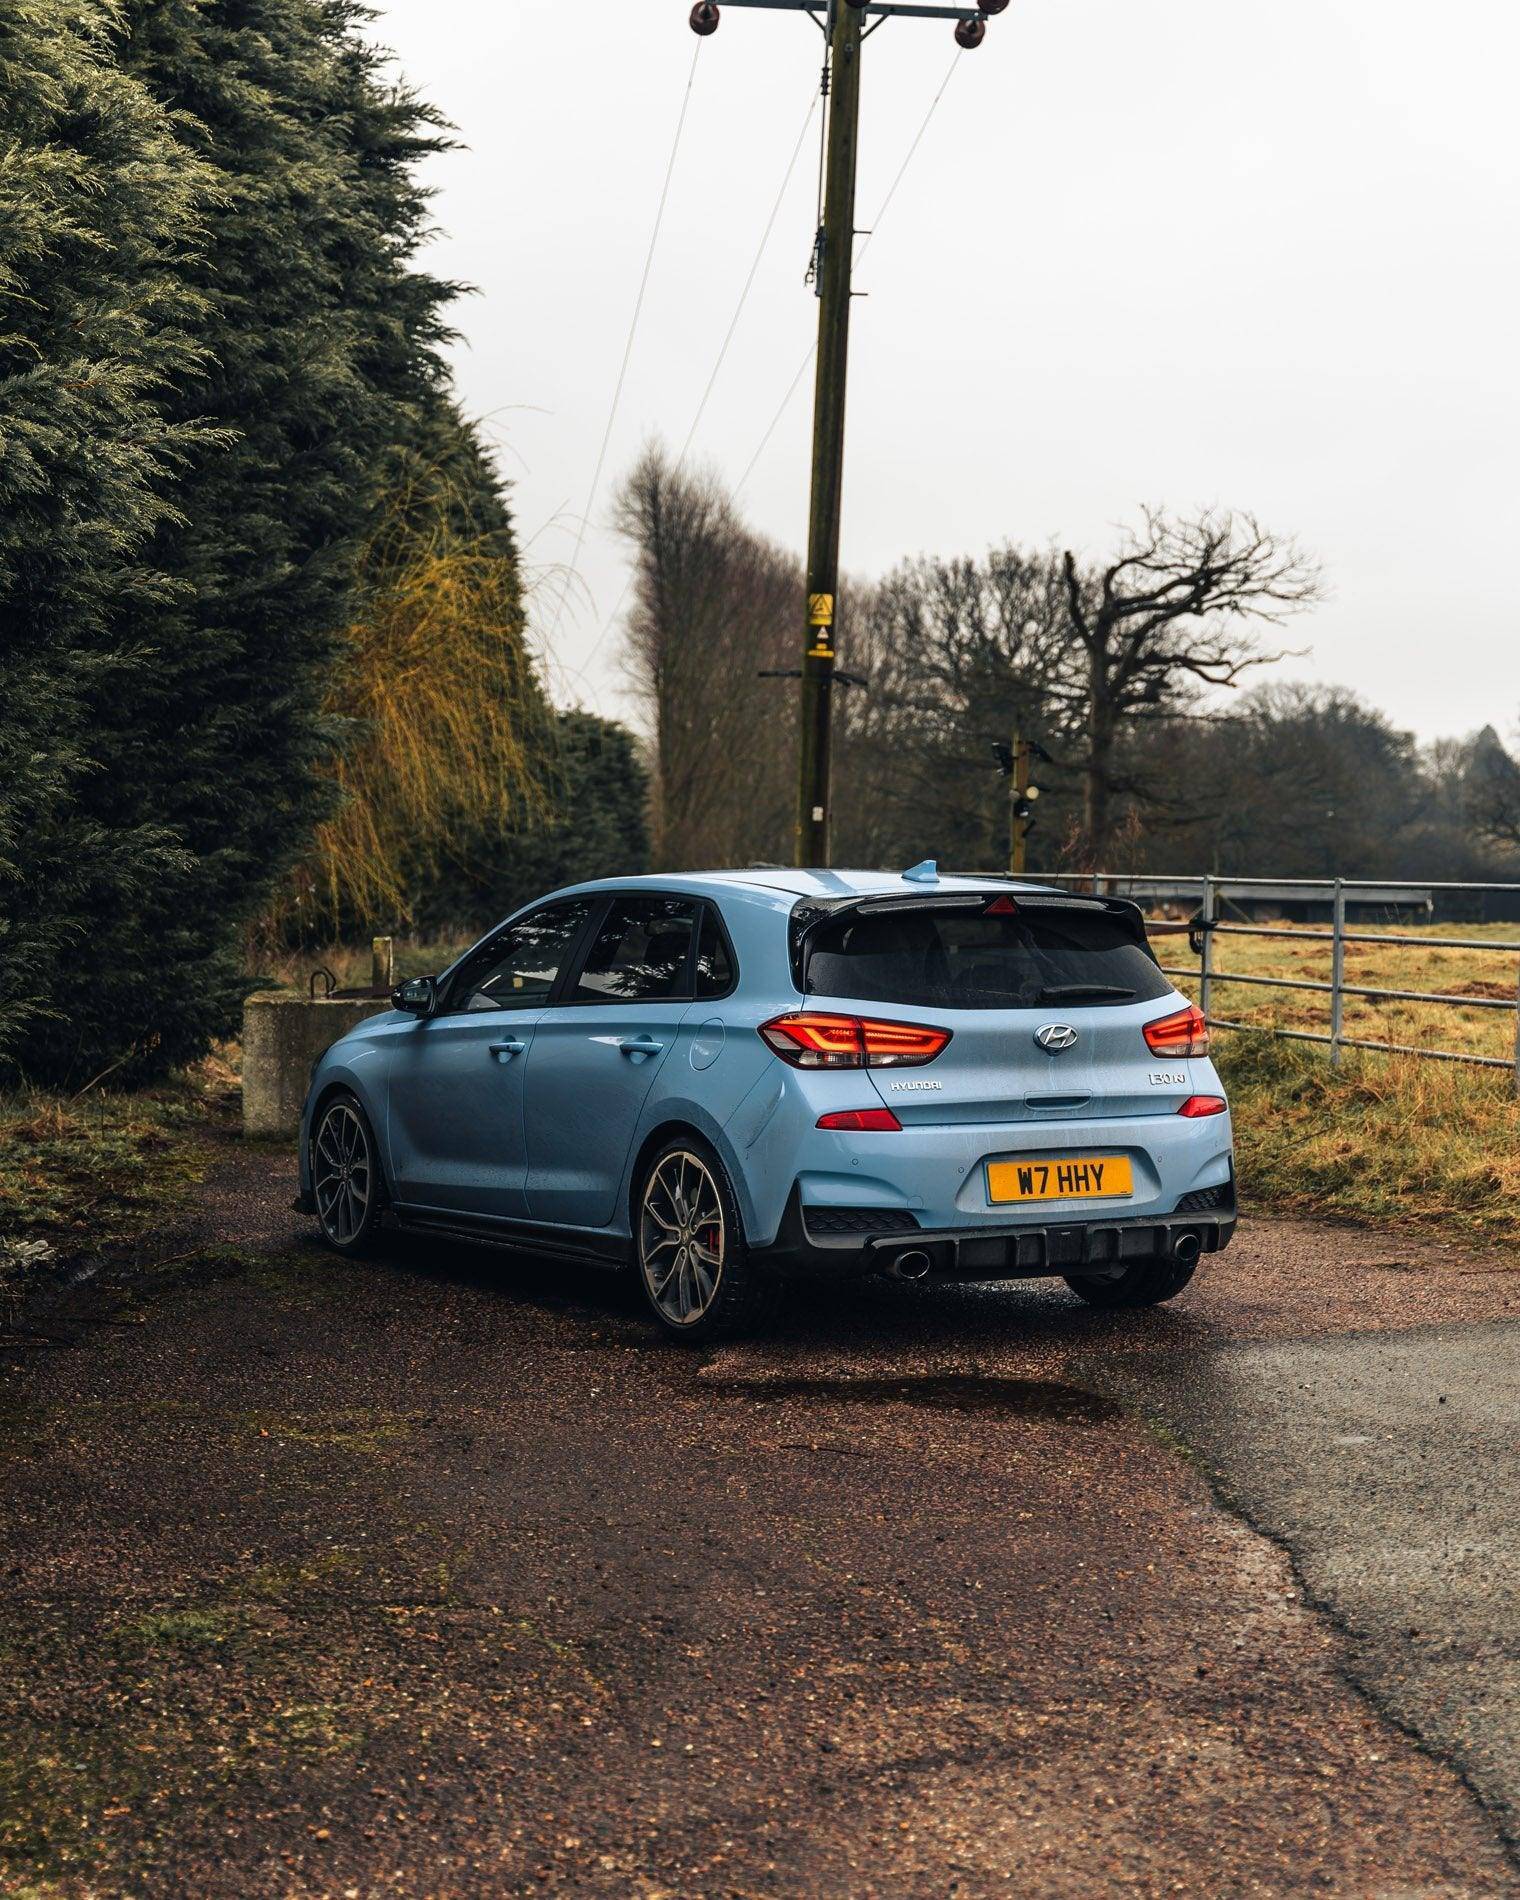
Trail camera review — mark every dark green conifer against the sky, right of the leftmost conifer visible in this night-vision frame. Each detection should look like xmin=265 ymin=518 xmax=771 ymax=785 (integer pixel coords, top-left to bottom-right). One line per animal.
xmin=10 ymin=0 xmax=463 ymax=1079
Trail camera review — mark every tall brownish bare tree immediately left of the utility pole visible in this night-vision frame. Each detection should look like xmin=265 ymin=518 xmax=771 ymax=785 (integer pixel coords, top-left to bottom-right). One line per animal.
xmin=618 ymin=447 xmax=802 ymax=866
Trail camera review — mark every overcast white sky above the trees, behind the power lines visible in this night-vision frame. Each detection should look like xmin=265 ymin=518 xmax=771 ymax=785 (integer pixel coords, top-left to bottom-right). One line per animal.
xmin=362 ymin=0 xmax=1520 ymax=737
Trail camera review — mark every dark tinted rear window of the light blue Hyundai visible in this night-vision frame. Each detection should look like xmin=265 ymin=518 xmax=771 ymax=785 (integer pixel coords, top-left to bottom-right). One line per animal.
xmin=804 ymin=910 xmax=1170 ymax=1009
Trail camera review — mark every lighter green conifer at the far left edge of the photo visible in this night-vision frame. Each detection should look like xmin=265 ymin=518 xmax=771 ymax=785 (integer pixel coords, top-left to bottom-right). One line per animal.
xmin=0 ymin=0 xmax=213 ymax=1079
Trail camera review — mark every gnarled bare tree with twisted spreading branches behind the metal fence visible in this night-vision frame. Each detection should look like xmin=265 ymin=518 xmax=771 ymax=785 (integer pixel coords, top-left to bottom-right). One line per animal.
xmin=1058 ymin=509 xmax=1322 ymax=868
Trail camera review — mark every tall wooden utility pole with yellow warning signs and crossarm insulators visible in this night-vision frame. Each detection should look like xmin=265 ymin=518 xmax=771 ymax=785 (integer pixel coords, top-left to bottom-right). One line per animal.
xmin=692 ymin=0 xmax=1009 ymax=865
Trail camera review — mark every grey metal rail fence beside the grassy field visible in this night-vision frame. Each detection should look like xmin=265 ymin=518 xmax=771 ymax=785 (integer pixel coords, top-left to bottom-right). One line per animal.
xmin=1032 ymin=872 xmax=1520 ymax=1096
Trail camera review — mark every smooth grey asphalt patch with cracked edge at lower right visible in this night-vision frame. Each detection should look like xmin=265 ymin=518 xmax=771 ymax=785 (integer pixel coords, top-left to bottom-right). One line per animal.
xmin=1117 ymin=1321 xmax=1520 ymax=1843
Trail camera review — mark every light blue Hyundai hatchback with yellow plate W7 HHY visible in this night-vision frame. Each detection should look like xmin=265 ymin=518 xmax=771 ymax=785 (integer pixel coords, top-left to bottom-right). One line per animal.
xmin=298 ymin=863 xmax=1235 ymax=1340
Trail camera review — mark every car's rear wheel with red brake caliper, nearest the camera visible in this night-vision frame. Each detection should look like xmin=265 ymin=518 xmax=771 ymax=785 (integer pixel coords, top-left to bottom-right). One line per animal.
xmin=633 ymin=1134 xmax=779 ymax=1345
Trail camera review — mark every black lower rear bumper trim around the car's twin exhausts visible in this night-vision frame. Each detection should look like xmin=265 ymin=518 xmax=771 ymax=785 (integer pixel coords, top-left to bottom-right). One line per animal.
xmin=764 ymin=1184 xmax=1237 ymax=1281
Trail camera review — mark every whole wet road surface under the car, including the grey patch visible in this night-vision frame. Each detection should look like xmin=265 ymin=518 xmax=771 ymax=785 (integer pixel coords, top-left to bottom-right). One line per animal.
xmin=0 ymin=1155 xmax=1520 ymax=1900
